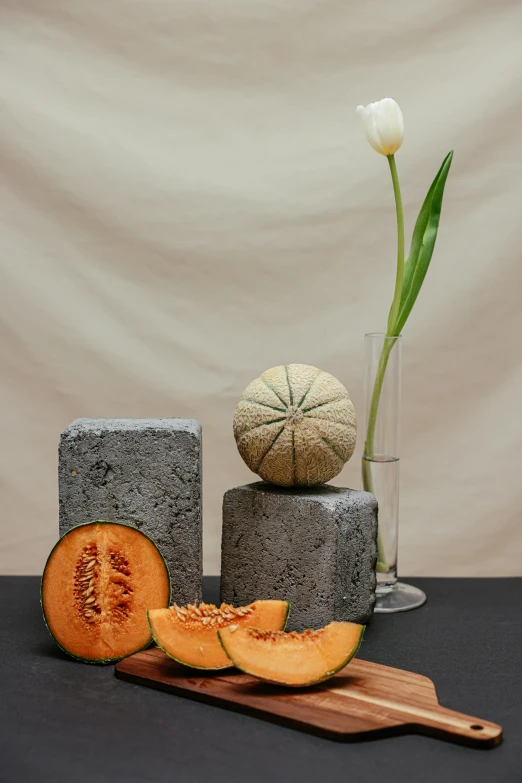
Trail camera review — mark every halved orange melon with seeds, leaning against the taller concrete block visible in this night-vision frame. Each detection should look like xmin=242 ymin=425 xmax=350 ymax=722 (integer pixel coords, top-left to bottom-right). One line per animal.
xmin=41 ymin=521 xmax=170 ymax=663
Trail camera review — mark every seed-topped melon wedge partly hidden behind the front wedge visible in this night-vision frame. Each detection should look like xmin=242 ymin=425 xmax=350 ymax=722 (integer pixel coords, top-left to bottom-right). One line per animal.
xmin=147 ymin=601 xmax=290 ymax=669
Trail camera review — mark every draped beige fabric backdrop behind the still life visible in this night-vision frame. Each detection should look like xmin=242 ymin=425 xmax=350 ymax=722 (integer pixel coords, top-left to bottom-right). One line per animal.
xmin=0 ymin=0 xmax=522 ymax=575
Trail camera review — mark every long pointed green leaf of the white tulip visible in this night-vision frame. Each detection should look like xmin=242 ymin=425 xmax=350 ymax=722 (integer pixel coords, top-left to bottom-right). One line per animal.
xmin=388 ymin=150 xmax=453 ymax=335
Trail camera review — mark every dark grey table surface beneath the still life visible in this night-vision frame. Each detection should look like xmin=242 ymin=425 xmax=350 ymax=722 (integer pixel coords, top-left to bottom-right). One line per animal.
xmin=0 ymin=576 xmax=522 ymax=783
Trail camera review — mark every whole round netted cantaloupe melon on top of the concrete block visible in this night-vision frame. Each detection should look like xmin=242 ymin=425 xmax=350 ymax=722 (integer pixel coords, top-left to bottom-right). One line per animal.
xmin=234 ymin=364 xmax=357 ymax=487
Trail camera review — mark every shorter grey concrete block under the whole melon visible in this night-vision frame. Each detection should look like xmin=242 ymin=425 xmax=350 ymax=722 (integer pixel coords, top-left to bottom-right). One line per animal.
xmin=221 ymin=482 xmax=377 ymax=631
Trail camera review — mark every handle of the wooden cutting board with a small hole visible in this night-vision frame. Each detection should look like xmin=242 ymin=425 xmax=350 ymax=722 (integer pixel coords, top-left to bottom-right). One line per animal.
xmin=412 ymin=705 xmax=502 ymax=747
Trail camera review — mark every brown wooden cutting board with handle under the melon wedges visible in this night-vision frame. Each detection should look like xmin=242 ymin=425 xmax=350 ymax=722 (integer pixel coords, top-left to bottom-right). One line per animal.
xmin=116 ymin=647 xmax=502 ymax=748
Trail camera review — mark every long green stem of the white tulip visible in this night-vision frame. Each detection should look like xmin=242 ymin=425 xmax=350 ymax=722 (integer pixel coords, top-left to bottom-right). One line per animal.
xmin=362 ymin=155 xmax=404 ymax=573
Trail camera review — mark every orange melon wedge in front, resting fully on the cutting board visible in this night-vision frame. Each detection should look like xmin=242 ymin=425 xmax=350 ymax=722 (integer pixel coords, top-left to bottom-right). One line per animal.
xmin=218 ymin=622 xmax=364 ymax=687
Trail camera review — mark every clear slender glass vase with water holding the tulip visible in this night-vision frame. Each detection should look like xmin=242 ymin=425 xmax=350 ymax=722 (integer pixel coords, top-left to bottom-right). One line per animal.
xmin=362 ymin=333 xmax=426 ymax=612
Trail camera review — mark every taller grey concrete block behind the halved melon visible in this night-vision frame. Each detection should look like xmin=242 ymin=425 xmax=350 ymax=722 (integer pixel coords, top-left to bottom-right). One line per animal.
xmin=58 ymin=419 xmax=202 ymax=603
